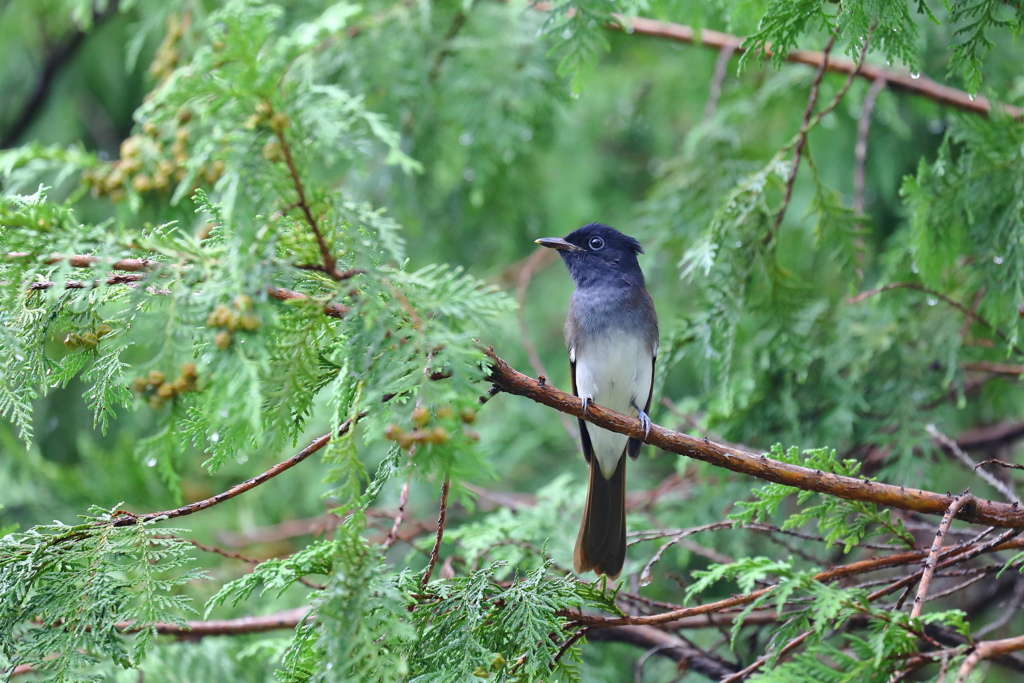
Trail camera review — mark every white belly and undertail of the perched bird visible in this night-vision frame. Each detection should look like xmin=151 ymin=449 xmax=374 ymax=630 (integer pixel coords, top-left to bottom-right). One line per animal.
xmin=570 ymin=330 xmax=655 ymax=478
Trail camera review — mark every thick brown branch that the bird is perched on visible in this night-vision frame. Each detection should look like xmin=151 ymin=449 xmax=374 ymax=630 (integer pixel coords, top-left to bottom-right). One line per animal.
xmin=485 ymin=348 xmax=1024 ymax=528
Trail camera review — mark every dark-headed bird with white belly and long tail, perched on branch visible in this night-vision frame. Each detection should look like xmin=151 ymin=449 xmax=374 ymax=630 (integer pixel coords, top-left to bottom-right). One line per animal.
xmin=537 ymin=223 xmax=658 ymax=579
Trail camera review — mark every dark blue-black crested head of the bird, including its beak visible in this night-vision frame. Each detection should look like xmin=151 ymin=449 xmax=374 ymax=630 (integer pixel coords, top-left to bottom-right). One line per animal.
xmin=537 ymin=223 xmax=644 ymax=289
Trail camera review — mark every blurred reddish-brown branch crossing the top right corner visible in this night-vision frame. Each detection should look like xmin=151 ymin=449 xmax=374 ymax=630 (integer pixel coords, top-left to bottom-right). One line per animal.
xmin=602 ymin=15 xmax=1024 ymax=119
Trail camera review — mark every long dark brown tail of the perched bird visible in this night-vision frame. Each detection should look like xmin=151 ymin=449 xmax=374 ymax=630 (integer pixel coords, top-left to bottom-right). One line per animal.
xmin=572 ymin=454 xmax=626 ymax=579
